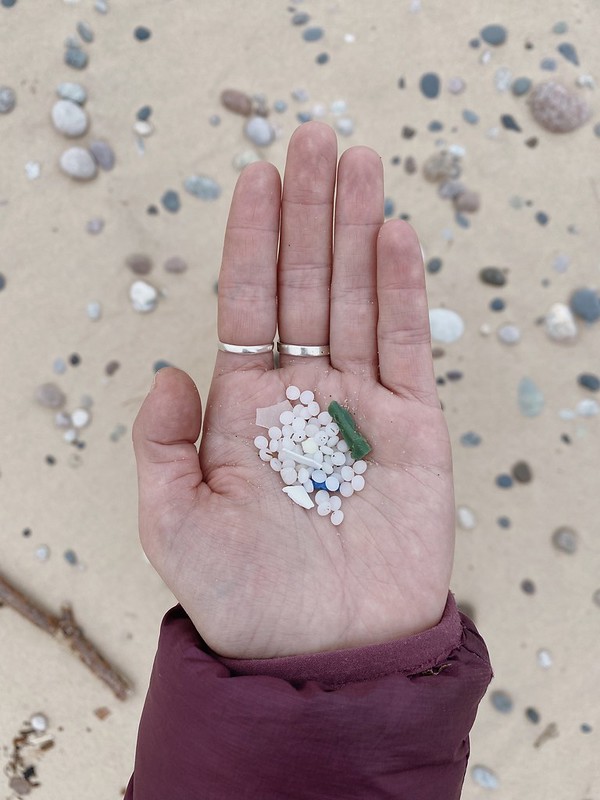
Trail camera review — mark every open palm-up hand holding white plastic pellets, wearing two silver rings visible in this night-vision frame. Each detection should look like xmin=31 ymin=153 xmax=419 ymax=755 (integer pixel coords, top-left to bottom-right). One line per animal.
xmin=133 ymin=122 xmax=454 ymax=658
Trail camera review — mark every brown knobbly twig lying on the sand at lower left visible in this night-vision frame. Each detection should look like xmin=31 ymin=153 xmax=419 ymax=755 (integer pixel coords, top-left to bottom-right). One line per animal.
xmin=0 ymin=574 xmax=132 ymax=700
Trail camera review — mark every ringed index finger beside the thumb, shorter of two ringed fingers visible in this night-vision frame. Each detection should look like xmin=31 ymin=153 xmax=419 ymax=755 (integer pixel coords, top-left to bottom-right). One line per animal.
xmin=216 ymin=163 xmax=281 ymax=373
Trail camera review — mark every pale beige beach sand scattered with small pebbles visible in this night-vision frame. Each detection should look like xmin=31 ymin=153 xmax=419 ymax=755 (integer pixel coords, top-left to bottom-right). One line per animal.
xmin=0 ymin=0 xmax=600 ymax=800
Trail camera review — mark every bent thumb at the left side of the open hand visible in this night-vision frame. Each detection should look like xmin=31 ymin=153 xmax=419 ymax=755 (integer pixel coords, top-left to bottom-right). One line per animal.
xmin=132 ymin=367 xmax=202 ymax=522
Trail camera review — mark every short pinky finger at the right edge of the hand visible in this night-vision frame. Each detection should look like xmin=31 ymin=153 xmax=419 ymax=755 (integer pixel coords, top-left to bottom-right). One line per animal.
xmin=377 ymin=220 xmax=439 ymax=407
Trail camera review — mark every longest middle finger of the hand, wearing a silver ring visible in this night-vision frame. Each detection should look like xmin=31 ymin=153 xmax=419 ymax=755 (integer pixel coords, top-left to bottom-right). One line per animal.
xmin=278 ymin=122 xmax=337 ymax=366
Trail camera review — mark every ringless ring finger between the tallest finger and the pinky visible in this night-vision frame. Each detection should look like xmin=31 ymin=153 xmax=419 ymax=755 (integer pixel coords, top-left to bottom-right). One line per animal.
xmin=330 ymin=147 xmax=383 ymax=378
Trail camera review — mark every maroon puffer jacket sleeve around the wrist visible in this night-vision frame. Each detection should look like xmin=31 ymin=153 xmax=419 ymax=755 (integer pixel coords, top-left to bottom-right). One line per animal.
xmin=125 ymin=593 xmax=493 ymax=800
